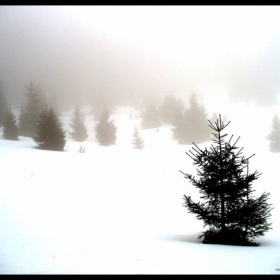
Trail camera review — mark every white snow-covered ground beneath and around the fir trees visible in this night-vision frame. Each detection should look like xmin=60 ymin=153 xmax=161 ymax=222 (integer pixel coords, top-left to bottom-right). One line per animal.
xmin=0 ymin=105 xmax=280 ymax=274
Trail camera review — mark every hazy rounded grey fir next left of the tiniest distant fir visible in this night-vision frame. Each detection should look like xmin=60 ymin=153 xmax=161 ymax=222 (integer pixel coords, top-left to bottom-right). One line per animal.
xmin=95 ymin=109 xmax=117 ymax=146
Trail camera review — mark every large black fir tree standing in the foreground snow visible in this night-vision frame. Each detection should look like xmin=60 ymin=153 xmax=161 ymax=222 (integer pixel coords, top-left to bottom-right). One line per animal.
xmin=181 ymin=116 xmax=272 ymax=245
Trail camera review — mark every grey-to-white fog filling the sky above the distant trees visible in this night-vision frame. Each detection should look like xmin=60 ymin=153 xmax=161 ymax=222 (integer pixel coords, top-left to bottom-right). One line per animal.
xmin=0 ymin=6 xmax=280 ymax=108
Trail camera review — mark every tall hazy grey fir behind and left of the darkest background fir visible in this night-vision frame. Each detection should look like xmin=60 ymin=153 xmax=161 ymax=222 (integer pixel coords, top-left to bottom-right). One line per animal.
xmin=19 ymin=82 xmax=43 ymax=137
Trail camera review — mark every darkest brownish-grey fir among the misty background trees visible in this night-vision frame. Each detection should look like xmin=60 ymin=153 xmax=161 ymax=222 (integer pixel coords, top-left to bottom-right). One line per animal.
xmin=33 ymin=106 xmax=66 ymax=151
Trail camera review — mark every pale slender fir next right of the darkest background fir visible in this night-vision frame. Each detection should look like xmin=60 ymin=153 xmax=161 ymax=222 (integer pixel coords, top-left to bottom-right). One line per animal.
xmin=69 ymin=106 xmax=88 ymax=142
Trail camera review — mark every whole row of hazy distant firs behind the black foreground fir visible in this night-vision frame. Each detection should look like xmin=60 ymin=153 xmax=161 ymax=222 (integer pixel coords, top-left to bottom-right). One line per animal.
xmin=0 ymin=79 xmax=280 ymax=152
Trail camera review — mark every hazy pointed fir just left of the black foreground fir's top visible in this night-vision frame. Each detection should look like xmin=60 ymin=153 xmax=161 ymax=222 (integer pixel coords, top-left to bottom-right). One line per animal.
xmin=173 ymin=93 xmax=210 ymax=145
